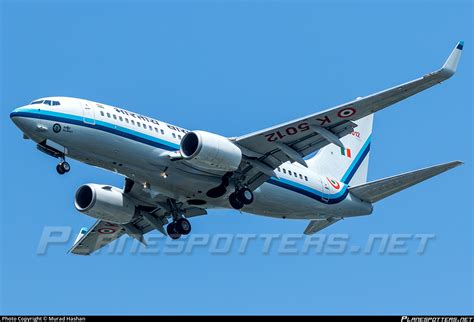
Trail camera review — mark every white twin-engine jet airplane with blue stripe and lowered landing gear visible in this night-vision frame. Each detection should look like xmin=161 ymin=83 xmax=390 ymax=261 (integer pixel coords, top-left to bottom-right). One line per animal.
xmin=10 ymin=41 xmax=464 ymax=255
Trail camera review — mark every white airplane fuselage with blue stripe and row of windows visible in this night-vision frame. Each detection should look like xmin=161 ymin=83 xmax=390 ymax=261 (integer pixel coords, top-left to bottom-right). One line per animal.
xmin=11 ymin=97 xmax=372 ymax=219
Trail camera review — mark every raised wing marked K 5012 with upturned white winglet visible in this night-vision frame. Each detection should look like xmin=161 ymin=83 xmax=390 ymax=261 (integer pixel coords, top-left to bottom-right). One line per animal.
xmin=232 ymin=42 xmax=463 ymax=189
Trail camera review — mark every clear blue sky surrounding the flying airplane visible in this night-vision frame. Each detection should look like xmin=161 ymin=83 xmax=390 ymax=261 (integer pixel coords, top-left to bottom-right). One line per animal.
xmin=0 ymin=0 xmax=474 ymax=314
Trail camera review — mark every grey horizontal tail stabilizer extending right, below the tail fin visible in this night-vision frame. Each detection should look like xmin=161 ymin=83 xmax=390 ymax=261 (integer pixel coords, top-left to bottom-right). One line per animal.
xmin=349 ymin=161 xmax=463 ymax=203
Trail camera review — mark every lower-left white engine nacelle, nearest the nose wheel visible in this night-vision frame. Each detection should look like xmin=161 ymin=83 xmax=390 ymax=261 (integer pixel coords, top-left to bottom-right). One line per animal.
xmin=74 ymin=183 xmax=135 ymax=224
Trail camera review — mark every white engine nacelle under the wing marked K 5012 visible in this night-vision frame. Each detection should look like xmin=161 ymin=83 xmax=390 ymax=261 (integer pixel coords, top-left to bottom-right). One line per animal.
xmin=181 ymin=131 xmax=242 ymax=171
